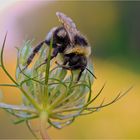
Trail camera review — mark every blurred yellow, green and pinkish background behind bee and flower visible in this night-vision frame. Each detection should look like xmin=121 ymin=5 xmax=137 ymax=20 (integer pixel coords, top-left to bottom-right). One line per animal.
xmin=0 ymin=0 xmax=140 ymax=139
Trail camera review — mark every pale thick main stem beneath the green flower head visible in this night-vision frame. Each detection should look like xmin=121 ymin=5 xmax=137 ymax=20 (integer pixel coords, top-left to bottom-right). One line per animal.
xmin=40 ymin=111 xmax=50 ymax=140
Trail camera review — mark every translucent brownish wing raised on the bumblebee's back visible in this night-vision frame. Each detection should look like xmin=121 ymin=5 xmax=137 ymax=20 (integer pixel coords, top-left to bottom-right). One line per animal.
xmin=56 ymin=12 xmax=79 ymax=44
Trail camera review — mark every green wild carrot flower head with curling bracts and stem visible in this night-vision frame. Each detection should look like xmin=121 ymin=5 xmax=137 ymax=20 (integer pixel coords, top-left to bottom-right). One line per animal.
xmin=0 ymin=33 xmax=130 ymax=139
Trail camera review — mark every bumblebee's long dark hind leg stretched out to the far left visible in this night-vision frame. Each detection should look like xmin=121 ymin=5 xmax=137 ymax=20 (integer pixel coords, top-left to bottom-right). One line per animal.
xmin=22 ymin=41 xmax=44 ymax=71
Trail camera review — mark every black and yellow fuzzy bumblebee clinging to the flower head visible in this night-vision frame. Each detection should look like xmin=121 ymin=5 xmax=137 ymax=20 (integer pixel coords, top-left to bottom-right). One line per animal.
xmin=24 ymin=12 xmax=96 ymax=81
